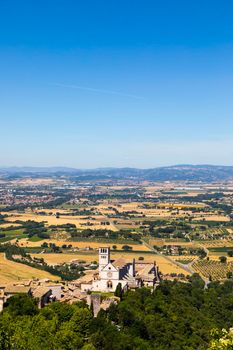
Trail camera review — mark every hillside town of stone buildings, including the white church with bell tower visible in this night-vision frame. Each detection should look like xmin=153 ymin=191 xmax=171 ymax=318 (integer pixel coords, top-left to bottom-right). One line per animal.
xmin=0 ymin=247 xmax=159 ymax=314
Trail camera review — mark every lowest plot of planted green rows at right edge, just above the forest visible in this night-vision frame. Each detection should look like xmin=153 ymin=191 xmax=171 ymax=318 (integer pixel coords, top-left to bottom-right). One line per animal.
xmin=192 ymin=260 xmax=233 ymax=281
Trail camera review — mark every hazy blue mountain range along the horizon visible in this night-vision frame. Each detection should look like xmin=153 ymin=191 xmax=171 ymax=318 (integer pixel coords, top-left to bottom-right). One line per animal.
xmin=0 ymin=164 xmax=233 ymax=182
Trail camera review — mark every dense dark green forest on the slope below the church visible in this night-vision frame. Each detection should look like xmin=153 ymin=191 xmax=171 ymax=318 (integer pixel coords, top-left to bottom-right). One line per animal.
xmin=0 ymin=275 xmax=233 ymax=350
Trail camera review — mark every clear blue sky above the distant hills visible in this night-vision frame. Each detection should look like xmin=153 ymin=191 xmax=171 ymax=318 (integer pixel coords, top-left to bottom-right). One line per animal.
xmin=0 ymin=0 xmax=233 ymax=168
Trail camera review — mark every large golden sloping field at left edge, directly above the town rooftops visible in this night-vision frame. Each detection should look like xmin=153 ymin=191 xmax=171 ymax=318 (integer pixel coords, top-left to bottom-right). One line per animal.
xmin=0 ymin=253 xmax=60 ymax=283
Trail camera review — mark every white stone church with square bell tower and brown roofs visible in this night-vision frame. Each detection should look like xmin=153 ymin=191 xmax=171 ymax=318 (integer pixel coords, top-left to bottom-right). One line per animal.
xmin=81 ymin=247 xmax=159 ymax=292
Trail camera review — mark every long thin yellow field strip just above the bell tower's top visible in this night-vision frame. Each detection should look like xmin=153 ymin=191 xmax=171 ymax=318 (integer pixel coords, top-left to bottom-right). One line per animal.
xmin=19 ymin=238 xmax=150 ymax=251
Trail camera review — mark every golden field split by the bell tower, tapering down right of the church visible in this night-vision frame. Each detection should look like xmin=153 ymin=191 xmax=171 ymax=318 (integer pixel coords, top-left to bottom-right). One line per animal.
xmin=32 ymin=251 xmax=188 ymax=275
